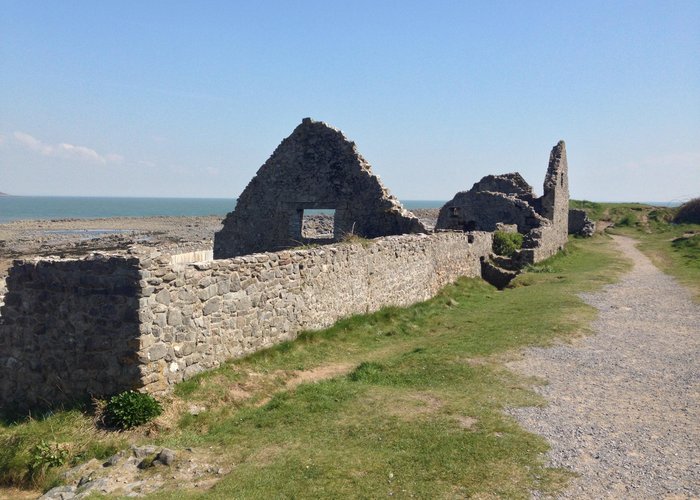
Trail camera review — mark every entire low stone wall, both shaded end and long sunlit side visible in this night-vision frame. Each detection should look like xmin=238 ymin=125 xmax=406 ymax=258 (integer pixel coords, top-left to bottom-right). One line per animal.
xmin=0 ymin=232 xmax=492 ymax=406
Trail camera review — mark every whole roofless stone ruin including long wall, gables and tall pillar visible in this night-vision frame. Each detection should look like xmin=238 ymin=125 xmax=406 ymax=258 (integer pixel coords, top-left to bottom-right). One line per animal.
xmin=0 ymin=118 xmax=580 ymax=408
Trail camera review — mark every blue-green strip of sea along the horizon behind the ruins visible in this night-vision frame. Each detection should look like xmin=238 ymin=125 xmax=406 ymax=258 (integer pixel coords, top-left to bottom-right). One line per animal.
xmin=0 ymin=196 xmax=445 ymax=223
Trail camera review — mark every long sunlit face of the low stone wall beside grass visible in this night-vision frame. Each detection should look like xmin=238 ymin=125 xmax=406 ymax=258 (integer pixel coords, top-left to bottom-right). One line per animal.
xmin=138 ymin=233 xmax=492 ymax=393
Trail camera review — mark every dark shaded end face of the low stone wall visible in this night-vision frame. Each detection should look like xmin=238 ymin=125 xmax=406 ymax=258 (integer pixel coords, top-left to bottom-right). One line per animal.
xmin=0 ymin=255 xmax=140 ymax=406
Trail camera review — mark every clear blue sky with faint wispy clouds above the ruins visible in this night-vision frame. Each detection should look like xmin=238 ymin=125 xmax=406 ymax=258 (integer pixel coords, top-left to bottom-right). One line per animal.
xmin=0 ymin=0 xmax=700 ymax=201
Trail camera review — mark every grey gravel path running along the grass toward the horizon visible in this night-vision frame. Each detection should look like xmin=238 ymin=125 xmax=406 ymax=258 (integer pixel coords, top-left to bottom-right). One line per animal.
xmin=509 ymin=236 xmax=700 ymax=499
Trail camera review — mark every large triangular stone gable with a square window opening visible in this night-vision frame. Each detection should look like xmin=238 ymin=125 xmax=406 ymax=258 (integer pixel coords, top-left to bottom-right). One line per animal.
xmin=214 ymin=118 xmax=427 ymax=259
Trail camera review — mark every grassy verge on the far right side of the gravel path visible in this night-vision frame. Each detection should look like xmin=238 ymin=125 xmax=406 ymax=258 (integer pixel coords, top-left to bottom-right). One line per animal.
xmin=571 ymin=201 xmax=700 ymax=302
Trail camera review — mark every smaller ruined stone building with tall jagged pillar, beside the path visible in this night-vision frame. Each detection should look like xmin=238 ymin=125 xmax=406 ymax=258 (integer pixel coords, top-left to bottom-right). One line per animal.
xmin=435 ymin=141 xmax=569 ymax=263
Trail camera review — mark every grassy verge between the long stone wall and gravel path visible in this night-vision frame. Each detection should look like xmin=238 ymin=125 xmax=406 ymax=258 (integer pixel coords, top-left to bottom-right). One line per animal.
xmin=0 ymin=237 xmax=626 ymax=498
